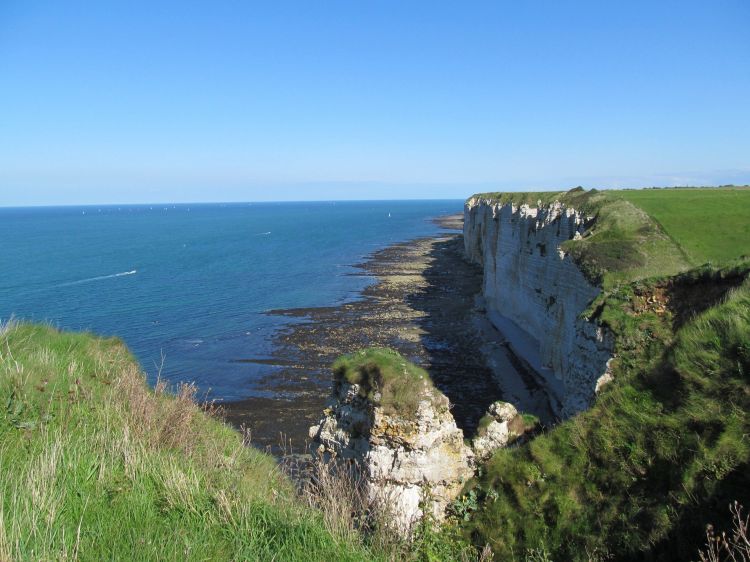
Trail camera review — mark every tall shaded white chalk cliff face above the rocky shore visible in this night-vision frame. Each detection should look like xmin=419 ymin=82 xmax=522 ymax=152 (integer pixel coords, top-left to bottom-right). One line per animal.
xmin=464 ymin=198 xmax=613 ymax=417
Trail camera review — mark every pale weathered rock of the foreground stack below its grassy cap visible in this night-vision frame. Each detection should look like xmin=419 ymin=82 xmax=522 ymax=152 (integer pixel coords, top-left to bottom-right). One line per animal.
xmin=310 ymin=376 xmax=473 ymax=531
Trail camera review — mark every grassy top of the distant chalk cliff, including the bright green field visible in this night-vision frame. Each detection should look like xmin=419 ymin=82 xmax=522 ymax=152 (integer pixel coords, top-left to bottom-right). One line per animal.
xmin=472 ymin=188 xmax=750 ymax=288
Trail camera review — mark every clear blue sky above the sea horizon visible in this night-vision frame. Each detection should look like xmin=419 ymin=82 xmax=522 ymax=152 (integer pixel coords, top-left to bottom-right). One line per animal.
xmin=0 ymin=0 xmax=750 ymax=205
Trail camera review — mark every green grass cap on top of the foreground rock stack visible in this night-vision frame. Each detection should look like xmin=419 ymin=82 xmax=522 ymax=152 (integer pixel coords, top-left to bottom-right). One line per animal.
xmin=333 ymin=348 xmax=448 ymax=418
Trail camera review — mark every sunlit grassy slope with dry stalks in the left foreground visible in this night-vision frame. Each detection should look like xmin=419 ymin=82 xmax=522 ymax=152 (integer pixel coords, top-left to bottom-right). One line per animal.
xmin=0 ymin=325 xmax=372 ymax=560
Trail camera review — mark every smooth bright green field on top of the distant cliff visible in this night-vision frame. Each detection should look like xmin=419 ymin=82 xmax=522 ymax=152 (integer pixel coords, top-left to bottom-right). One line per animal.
xmin=612 ymin=188 xmax=750 ymax=265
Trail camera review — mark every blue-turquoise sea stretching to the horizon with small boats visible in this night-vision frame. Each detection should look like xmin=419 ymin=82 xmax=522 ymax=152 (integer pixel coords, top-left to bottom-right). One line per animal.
xmin=0 ymin=200 xmax=462 ymax=400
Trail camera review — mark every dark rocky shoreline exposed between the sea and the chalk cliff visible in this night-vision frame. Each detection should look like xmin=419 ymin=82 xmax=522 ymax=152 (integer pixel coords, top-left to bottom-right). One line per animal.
xmin=224 ymin=215 xmax=552 ymax=454
